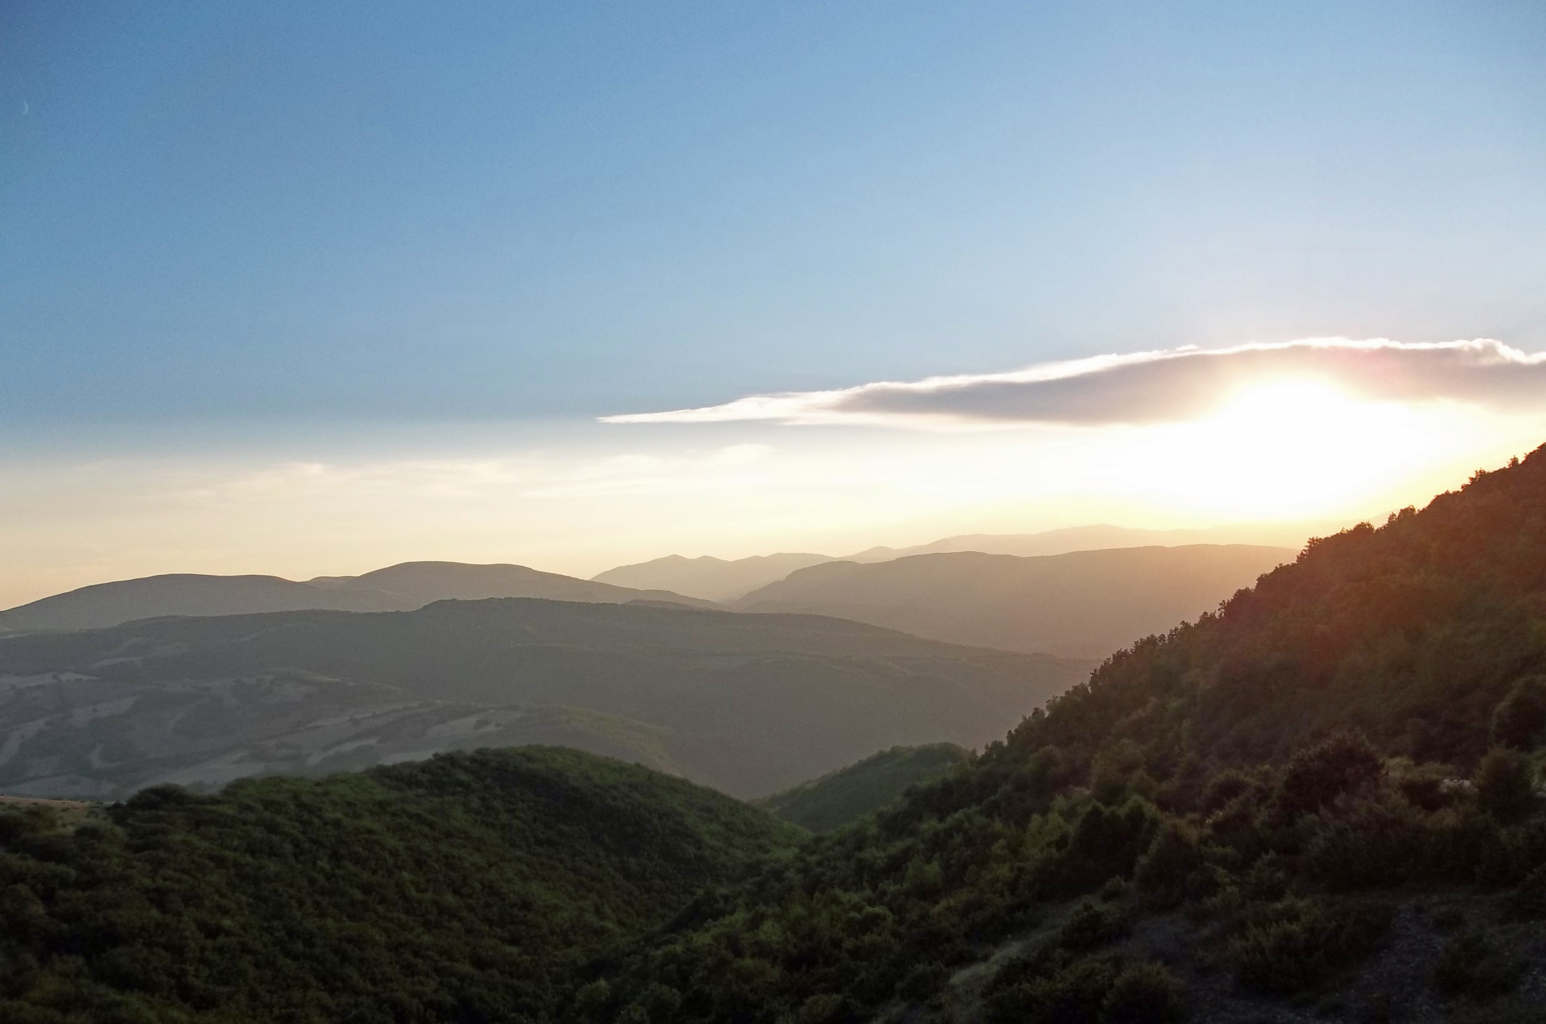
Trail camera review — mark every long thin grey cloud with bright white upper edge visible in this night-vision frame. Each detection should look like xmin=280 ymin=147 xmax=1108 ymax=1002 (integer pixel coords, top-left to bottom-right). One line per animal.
xmin=601 ymin=337 xmax=1546 ymax=427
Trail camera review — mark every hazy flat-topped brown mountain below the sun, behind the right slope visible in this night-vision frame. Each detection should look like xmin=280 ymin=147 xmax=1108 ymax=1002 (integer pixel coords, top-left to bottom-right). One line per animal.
xmin=736 ymin=544 xmax=1294 ymax=657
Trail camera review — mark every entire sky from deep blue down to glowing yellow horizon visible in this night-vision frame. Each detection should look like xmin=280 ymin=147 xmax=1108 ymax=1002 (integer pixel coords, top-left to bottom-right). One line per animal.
xmin=0 ymin=0 xmax=1546 ymax=606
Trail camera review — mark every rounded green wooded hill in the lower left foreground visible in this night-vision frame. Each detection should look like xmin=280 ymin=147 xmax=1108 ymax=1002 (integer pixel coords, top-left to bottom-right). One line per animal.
xmin=0 ymin=749 xmax=799 ymax=1024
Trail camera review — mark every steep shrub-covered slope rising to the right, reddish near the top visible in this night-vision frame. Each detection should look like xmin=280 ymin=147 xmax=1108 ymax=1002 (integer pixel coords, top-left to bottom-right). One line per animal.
xmin=584 ymin=449 xmax=1546 ymax=1024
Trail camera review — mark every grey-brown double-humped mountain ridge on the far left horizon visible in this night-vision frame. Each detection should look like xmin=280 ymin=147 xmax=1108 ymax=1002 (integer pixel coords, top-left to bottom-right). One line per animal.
xmin=0 ymin=561 xmax=711 ymax=631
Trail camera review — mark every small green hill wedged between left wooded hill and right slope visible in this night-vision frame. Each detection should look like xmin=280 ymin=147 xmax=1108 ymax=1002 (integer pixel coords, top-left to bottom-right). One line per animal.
xmin=756 ymin=742 xmax=971 ymax=832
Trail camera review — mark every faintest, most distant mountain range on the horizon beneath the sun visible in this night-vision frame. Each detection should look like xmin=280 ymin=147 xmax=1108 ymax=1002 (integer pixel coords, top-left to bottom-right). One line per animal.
xmin=591 ymin=523 xmax=1345 ymax=602
